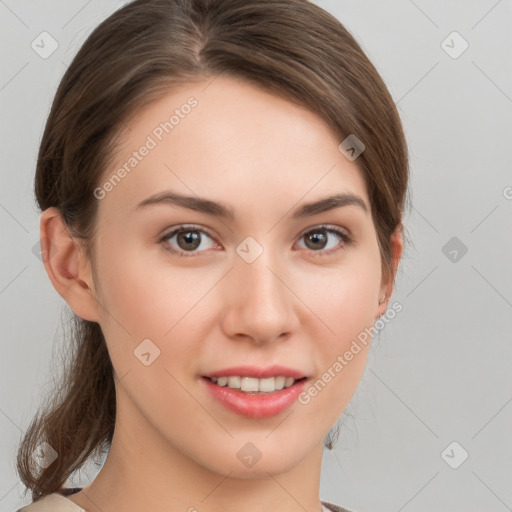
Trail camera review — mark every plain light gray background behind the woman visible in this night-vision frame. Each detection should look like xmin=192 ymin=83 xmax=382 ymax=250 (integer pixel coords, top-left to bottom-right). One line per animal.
xmin=0 ymin=0 xmax=512 ymax=512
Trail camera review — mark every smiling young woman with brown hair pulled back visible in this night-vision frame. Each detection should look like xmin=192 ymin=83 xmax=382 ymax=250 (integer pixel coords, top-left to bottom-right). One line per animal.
xmin=18 ymin=0 xmax=408 ymax=512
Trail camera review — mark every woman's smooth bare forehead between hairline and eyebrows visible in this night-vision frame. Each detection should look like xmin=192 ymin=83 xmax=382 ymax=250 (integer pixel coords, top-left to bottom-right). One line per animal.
xmin=97 ymin=76 xmax=367 ymax=218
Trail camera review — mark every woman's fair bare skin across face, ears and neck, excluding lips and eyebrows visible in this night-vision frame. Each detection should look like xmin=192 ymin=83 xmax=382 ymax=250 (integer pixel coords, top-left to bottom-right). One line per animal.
xmin=41 ymin=76 xmax=402 ymax=512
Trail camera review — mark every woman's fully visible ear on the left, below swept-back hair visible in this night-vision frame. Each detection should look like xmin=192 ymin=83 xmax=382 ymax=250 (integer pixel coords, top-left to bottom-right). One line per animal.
xmin=40 ymin=207 xmax=99 ymax=322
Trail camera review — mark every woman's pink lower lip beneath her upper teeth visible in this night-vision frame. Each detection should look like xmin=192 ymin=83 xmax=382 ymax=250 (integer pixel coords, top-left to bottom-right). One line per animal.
xmin=201 ymin=377 xmax=307 ymax=418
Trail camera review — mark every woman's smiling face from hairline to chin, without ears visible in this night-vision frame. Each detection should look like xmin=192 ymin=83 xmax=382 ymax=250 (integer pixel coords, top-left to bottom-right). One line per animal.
xmin=86 ymin=77 xmax=384 ymax=478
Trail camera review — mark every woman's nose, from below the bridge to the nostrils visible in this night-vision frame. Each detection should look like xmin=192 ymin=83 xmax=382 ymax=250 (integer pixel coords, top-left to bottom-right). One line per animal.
xmin=222 ymin=249 xmax=300 ymax=345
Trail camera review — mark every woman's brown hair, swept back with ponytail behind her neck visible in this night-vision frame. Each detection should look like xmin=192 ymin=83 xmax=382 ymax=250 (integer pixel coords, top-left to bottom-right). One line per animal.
xmin=17 ymin=0 xmax=408 ymax=501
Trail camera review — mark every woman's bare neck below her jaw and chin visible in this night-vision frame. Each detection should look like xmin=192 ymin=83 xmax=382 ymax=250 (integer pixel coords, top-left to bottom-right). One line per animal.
xmin=68 ymin=394 xmax=323 ymax=512
